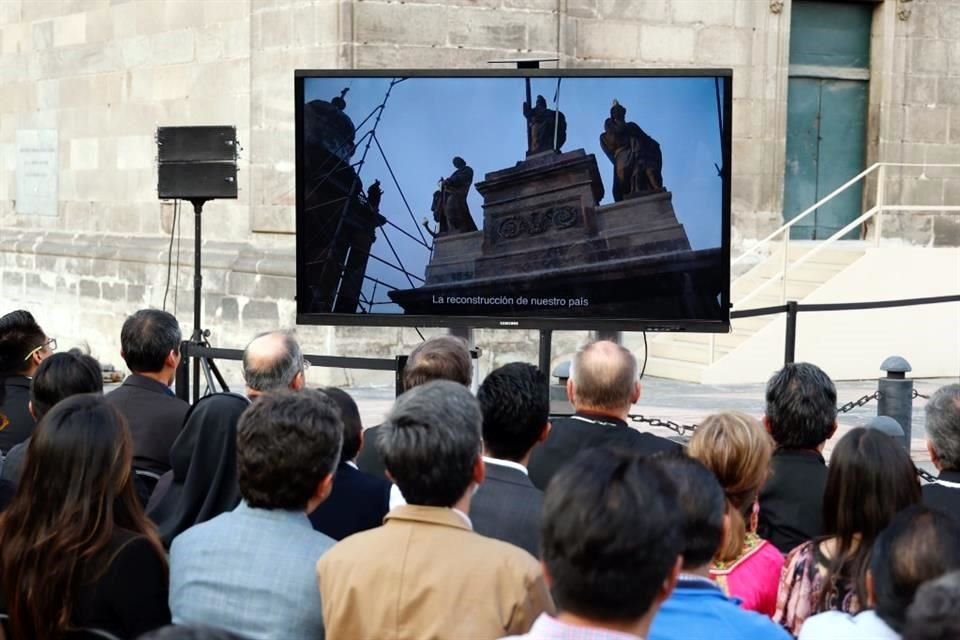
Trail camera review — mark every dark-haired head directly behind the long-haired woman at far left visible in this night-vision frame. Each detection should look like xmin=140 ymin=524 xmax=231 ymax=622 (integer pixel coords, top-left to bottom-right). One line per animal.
xmin=30 ymin=349 xmax=103 ymax=422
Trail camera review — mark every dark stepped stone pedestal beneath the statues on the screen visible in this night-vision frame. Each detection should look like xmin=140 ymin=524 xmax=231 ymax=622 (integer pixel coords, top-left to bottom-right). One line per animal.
xmin=390 ymin=149 xmax=724 ymax=319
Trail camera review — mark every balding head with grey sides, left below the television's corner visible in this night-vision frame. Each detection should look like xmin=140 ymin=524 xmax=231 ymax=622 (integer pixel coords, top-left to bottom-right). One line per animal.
xmin=243 ymin=331 xmax=304 ymax=393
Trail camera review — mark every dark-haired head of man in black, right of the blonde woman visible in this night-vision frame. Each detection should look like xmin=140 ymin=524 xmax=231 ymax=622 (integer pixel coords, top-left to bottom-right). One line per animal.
xmin=766 ymin=362 xmax=837 ymax=449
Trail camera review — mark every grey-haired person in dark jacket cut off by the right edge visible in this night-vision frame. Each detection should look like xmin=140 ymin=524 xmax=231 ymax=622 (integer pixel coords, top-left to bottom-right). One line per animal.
xmin=923 ymin=384 xmax=960 ymax=518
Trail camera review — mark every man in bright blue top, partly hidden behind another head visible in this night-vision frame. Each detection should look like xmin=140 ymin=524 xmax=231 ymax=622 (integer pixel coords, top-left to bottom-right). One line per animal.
xmin=638 ymin=454 xmax=790 ymax=640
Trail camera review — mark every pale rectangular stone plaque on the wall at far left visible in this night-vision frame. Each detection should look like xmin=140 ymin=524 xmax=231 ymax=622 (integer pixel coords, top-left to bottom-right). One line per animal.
xmin=17 ymin=129 xmax=60 ymax=216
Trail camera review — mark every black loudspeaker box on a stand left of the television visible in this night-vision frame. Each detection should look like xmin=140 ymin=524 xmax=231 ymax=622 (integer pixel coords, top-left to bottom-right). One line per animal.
xmin=157 ymin=126 xmax=238 ymax=200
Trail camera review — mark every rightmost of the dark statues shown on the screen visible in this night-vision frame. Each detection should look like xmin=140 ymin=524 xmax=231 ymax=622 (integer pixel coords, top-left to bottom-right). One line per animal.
xmin=600 ymin=100 xmax=664 ymax=202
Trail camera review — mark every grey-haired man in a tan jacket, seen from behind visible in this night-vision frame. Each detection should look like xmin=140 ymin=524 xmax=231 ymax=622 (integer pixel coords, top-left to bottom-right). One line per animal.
xmin=317 ymin=381 xmax=552 ymax=640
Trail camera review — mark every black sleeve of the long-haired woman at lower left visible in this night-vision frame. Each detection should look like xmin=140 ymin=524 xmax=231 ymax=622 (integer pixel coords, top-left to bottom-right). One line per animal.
xmin=104 ymin=537 xmax=170 ymax=638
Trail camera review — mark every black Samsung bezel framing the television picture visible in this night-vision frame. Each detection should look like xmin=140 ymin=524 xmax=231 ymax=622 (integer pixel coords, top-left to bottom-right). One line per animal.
xmin=294 ymin=68 xmax=733 ymax=333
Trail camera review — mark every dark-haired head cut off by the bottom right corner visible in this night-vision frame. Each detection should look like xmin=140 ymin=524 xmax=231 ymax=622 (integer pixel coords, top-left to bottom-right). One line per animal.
xmin=902 ymin=571 xmax=960 ymax=640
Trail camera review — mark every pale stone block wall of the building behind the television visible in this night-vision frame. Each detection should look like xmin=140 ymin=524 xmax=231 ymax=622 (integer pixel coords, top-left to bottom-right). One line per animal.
xmin=0 ymin=0 xmax=960 ymax=384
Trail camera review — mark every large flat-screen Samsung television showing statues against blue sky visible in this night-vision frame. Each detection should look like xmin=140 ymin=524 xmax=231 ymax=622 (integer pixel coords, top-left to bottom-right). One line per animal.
xmin=295 ymin=69 xmax=732 ymax=332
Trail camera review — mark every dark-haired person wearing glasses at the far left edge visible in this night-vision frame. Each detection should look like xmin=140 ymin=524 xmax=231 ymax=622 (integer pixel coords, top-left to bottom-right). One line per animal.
xmin=0 ymin=310 xmax=57 ymax=455
